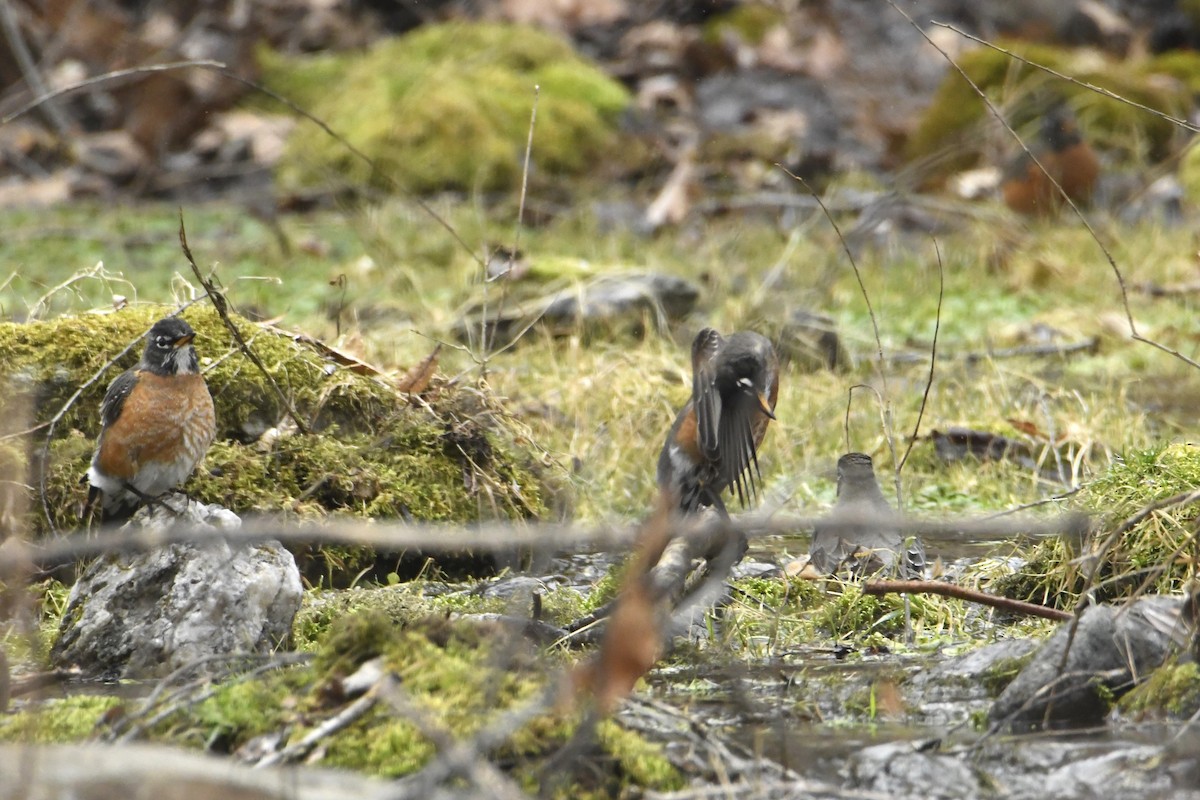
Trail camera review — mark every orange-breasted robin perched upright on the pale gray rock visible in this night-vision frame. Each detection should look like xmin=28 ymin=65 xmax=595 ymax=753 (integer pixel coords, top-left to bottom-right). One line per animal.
xmin=86 ymin=317 xmax=216 ymax=522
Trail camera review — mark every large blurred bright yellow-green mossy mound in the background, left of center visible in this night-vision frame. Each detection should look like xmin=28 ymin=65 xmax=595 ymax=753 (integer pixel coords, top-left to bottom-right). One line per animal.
xmin=259 ymin=23 xmax=629 ymax=192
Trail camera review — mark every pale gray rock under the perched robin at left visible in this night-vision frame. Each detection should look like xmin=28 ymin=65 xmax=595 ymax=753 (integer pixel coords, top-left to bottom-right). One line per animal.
xmin=50 ymin=495 xmax=301 ymax=678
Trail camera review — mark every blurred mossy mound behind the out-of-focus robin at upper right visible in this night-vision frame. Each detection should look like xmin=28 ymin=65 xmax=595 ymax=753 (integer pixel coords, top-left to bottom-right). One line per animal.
xmin=906 ymin=42 xmax=1200 ymax=181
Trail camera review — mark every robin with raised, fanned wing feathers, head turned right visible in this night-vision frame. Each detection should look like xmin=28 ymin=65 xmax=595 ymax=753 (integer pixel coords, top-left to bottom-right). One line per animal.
xmin=658 ymin=327 xmax=779 ymax=517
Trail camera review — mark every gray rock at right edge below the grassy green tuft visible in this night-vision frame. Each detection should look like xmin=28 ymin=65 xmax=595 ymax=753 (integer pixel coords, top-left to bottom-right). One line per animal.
xmin=989 ymin=597 xmax=1190 ymax=727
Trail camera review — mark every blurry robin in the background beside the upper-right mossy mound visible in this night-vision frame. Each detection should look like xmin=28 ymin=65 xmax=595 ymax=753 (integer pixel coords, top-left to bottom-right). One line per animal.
xmin=1001 ymin=104 xmax=1100 ymax=217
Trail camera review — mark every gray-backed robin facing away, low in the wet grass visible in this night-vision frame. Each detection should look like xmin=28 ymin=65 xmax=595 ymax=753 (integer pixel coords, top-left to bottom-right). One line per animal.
xmin=809 ymin=453 xmax=925 ymax=578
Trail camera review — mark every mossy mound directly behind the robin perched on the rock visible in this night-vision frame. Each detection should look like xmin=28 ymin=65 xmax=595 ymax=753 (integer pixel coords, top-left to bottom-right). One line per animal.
xmin=0 ymin=303 xmax=544 ymax=542
